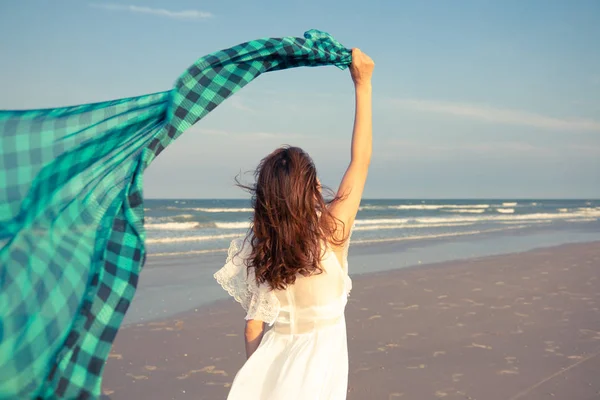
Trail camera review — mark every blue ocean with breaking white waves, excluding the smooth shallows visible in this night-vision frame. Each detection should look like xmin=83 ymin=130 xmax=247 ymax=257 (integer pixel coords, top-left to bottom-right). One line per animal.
xmin=145 ymin=199 xmax=600 ymax=257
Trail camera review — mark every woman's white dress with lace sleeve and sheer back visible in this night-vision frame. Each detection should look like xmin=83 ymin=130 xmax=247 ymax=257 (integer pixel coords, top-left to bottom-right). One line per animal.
xmin=215 ymin=234 xmax=352 ymax=400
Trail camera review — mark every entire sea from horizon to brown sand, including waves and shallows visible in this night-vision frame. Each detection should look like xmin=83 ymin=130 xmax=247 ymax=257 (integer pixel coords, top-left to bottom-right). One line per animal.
xmin=125 ymin=199 xmax=600 ymax=325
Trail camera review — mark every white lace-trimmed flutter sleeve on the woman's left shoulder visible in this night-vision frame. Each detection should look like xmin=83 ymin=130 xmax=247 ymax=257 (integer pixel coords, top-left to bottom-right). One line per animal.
xmin=214 ymin=238 xmax=280 ymax=325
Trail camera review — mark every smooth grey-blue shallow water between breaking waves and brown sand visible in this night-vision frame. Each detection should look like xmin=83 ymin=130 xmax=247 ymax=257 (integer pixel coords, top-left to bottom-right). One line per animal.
xmin=123 ymin=229 xmax=600 ymax=326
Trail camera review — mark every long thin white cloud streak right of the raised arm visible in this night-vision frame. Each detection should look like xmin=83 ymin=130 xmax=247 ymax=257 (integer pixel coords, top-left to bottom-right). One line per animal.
xmin=392 ymin=99 xmax=600 ymax=132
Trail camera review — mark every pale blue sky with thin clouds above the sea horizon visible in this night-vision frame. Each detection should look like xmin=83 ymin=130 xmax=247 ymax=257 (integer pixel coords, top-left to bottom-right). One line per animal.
xmin=0 ymin=0 xmax=600 ymax=198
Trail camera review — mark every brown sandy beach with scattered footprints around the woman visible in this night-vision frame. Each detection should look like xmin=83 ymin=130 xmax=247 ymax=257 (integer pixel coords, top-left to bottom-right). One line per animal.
xmin=103 ymin=242 xmax=600 ymax=400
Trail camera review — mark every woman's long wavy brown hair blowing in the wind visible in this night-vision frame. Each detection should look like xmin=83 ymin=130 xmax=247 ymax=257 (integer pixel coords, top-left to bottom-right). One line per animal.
xmin=236 ymin=146 xmax=346 ymax=289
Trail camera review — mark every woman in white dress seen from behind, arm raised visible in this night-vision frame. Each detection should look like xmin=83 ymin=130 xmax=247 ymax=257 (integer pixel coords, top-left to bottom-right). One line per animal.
xmin=215 ymin=49 xmax=374 ymax=400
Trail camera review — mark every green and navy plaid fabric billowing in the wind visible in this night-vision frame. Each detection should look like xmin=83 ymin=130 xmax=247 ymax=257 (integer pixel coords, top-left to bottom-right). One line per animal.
xmin=0 ymin=30 xmax=351 ymax=399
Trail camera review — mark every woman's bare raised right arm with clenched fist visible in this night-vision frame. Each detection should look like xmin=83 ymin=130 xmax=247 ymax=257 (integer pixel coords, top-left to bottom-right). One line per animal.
xmin=330 ymin=49 xmax=375 ymax=238
